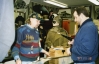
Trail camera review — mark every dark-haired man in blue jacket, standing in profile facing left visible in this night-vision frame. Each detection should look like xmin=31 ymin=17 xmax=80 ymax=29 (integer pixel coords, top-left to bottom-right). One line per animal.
xmin=68 ymin=7 xmax=98 ymax=64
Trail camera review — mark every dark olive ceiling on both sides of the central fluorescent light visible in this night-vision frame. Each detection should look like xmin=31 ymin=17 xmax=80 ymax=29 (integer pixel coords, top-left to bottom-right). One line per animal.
xmin=31 ymin=0 xmax=94 ymax=7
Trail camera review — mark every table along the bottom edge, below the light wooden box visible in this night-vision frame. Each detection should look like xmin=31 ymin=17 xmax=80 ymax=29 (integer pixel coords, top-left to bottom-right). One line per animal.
xmin=1 ymin=56 xmax=73 ymax=64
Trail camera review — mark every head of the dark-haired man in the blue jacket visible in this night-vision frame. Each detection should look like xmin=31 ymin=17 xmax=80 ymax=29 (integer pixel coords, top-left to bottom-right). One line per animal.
xmin=73 ymin=7 xmax=89 ymax=24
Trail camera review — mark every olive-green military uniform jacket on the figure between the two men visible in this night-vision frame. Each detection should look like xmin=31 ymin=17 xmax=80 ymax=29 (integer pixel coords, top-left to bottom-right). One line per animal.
xmin=45 ymin=26 xmax=68 ymax=47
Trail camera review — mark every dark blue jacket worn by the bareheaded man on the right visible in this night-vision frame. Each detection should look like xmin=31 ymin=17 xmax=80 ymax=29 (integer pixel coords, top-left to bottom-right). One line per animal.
xmin=71 ymin=19 xmax=98 ymax=63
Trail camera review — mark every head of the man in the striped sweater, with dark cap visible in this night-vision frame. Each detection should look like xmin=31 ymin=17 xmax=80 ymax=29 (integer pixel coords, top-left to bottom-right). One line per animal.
xmin=27 ymin=13 xmax=41 ymax=28
